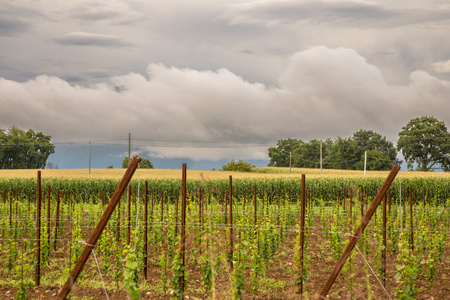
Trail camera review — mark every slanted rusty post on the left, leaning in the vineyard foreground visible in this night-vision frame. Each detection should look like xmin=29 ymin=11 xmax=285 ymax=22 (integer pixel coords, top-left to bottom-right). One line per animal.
xmin=57 ymin=156 xmax=141 ymax=300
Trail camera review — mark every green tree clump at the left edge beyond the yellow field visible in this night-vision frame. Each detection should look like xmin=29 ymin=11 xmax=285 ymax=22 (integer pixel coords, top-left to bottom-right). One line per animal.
xmin=0 ymin=125 xmax=55 ymax=169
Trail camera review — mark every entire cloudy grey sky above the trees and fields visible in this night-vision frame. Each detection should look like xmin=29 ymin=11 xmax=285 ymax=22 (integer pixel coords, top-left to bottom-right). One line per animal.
xmin=0 ymin=0 xmax=450 ymax=167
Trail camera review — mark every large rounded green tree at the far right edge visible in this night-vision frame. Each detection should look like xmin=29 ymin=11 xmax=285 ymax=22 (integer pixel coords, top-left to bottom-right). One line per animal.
xmin=397 ymin=116 xmax=450 ymax=171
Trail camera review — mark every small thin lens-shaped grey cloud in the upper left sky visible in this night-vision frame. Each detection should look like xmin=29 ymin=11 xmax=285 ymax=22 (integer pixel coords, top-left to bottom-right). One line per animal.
xmin=53 ymin=32 xmax=131 ymax=47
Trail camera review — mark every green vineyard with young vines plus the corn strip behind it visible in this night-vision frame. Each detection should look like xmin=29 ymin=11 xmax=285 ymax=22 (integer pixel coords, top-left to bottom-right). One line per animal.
xmin=0 ymin=163 xmax=450 ymax=299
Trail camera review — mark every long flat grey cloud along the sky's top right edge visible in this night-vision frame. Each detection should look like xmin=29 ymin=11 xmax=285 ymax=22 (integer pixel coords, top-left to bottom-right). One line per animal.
xmin=225 ymin=1 xmax=450 ymax=28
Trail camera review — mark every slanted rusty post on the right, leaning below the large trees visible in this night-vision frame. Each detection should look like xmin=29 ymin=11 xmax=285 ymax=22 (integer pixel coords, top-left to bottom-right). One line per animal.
xmin=318 ymin=165 xmax=400 ymax=299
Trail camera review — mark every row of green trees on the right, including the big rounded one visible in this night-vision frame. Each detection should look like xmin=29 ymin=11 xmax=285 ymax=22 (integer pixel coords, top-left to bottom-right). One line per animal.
xmin=268 ymin=116 xmax=450 ymax=171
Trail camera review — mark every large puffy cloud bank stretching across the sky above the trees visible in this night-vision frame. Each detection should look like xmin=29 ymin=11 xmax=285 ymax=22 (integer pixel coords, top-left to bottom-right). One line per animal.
xmin=0 ymin=46 xmax=450 ymax=160
